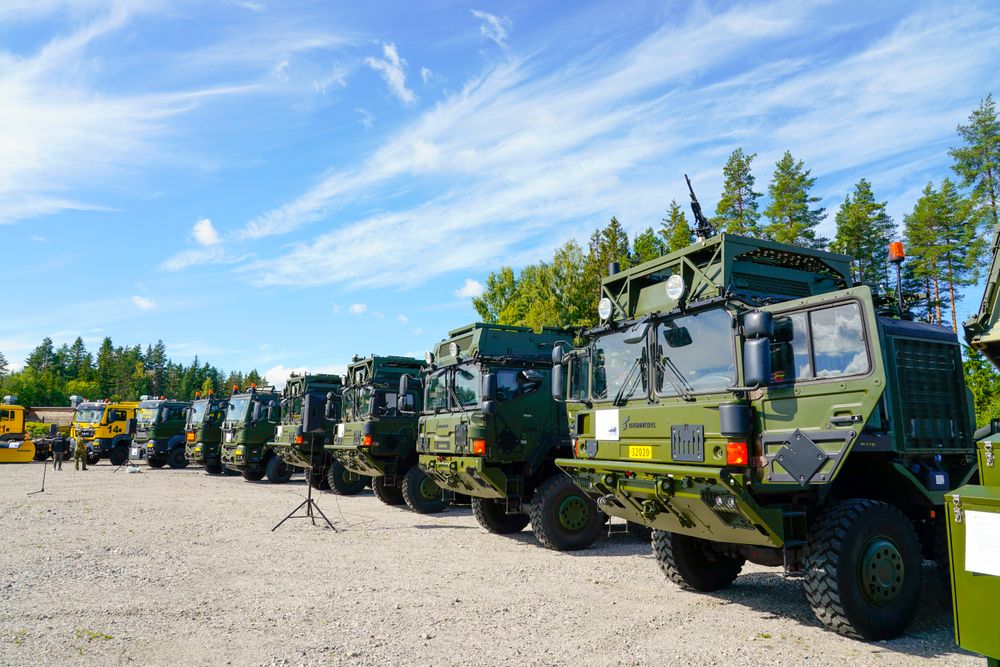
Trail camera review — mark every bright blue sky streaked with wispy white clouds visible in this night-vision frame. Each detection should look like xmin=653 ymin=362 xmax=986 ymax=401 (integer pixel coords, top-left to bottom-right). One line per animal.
xmin=0 ymin=0 xmax=1000 ymax=383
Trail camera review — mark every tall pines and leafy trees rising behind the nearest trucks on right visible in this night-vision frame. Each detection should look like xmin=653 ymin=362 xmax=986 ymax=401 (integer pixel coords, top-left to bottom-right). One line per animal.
xmin=473 ymin=95 xmax=1000 ymax=420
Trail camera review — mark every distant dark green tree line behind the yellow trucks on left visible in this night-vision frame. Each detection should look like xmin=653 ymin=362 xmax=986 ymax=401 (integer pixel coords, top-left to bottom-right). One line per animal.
xmin=0 ymin=337 xmax=264 ymax=406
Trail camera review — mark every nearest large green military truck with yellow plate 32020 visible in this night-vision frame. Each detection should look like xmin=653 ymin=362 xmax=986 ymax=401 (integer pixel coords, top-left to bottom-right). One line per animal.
xmin=552 ymin=231 xmax=976 ymax=640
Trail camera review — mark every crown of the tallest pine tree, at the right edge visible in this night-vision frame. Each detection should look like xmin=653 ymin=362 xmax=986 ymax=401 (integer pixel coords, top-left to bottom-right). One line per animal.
xmin=948 ymin=95 xmax=1000 ymax=229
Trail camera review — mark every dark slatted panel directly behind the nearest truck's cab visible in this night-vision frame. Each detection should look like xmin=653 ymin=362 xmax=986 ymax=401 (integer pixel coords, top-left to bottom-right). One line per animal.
xmin=879 ymin=318 xmax=975 ymax=453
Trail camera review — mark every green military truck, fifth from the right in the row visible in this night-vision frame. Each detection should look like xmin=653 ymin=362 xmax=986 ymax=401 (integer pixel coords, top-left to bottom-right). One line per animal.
xmin=222 ymin=385 xmax=284 ymax=484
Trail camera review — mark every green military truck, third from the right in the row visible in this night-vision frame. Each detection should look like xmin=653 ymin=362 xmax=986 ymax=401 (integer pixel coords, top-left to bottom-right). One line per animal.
xmin=327 ymin=356 xmax=426 ymax=506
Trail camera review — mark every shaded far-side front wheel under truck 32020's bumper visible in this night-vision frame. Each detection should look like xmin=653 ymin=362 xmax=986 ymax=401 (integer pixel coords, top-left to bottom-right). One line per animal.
xmin=653 ymin=530 xmax=746 ymax=593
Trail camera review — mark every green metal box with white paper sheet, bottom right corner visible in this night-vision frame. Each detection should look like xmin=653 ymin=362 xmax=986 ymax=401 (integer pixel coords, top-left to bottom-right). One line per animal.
xmin=947 ymin=482 xmax=1000 ymax=665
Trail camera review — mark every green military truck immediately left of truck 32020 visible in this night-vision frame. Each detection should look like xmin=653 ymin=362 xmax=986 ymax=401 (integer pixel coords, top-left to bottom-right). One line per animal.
xmin=414 ymin=324 xmax=604 ymax=550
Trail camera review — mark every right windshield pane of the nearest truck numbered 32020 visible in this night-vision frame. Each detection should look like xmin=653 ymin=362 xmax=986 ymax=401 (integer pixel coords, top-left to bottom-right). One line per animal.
xmin=655 ymin=309 xmax=736 ymax=396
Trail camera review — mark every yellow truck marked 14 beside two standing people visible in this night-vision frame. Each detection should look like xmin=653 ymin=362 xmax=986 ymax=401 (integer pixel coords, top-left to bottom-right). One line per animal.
xmin=69 ymin=400 xmax=139 ymax=466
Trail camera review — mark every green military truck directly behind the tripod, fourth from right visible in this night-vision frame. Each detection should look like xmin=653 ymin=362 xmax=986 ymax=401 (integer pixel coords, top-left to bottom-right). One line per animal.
xmin=270 ymin=373 xmax=356 ymax=491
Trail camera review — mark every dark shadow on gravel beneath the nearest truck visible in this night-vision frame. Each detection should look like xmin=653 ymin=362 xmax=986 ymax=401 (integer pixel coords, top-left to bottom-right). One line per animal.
xmin=704 ymin=563 xmax=969 ymax=658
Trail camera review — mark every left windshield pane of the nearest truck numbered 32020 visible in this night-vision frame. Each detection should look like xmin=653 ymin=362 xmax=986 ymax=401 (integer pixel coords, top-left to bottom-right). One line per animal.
xmin=590 ymin=331 xmax=648 ymax=401
